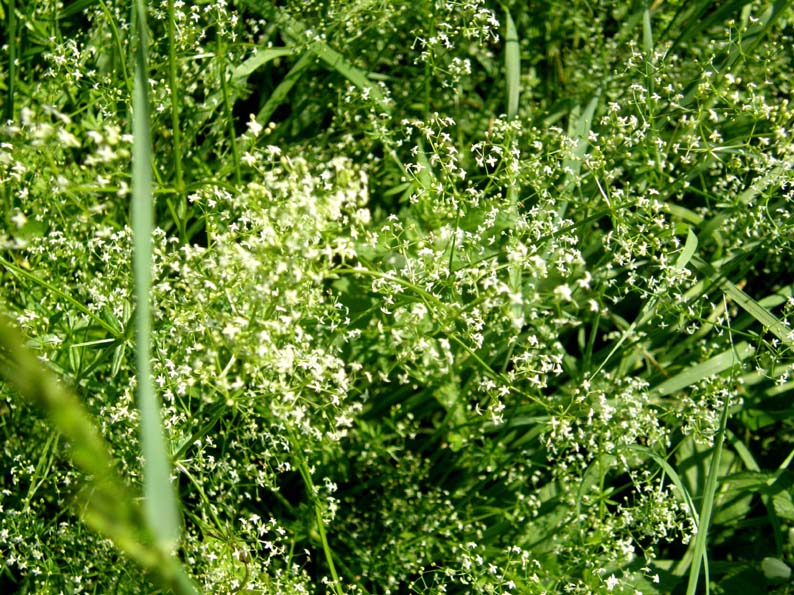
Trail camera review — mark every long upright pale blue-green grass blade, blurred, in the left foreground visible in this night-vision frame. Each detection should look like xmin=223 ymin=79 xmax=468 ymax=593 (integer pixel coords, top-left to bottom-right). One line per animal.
xmin=132 ymin=0 xmax=179 ymax=551
